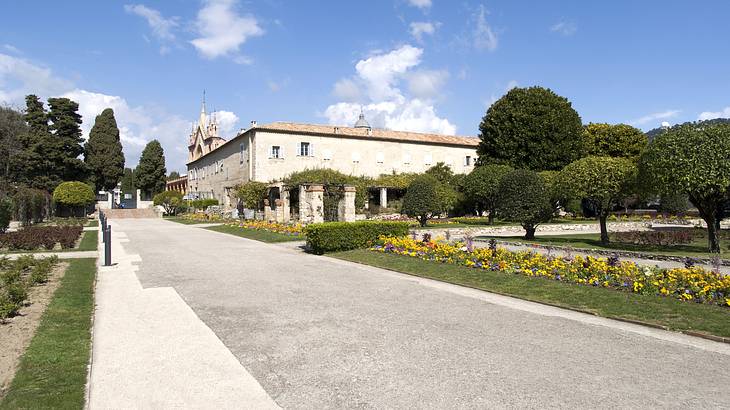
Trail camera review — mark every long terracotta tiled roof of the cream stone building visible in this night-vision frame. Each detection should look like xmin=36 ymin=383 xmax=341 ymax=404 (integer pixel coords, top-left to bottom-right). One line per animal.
xmin=254 ymin=122 xmax=479 ymax=147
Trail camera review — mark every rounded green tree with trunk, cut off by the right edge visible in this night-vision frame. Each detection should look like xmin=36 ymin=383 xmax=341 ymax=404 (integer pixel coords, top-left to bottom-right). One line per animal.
xmin=639 ymin=122 xmax=730 ymax=253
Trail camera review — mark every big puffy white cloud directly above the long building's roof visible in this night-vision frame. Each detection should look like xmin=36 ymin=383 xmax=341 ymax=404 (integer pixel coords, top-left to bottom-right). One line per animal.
xmin=323 ymin=45 xmax=456 ymax=134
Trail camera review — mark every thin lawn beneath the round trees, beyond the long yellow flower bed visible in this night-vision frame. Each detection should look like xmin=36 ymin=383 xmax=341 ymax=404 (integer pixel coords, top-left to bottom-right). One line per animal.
xmin=478 ymin=230 xmax=730 ymax=257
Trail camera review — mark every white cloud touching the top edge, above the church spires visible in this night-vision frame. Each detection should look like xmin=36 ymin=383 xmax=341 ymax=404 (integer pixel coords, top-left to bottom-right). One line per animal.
xmin=190 ymin=0 xmax=264 ymax=60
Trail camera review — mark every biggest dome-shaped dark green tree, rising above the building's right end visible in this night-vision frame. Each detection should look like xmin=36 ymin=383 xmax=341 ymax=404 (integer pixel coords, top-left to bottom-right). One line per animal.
xmin=477 ymin=87 xmax=584 ymax=171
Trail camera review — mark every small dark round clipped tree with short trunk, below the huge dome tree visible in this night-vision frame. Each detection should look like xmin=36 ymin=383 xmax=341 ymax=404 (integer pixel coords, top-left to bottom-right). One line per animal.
xmin=497 ymin=169 xmax=553 ymax=239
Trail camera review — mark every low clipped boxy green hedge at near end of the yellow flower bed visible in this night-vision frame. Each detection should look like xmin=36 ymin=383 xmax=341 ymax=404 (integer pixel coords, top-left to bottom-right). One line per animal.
xmin=304 ymin=221 xmax=408 ymax=255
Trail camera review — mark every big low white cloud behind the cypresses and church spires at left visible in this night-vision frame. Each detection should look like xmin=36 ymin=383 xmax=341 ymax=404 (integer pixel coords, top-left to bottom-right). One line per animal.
xmin=0 ymin=53 xmax=238 ymax=171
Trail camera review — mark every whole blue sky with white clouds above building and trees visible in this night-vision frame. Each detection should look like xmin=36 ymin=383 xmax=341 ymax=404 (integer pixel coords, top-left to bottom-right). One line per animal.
xmin=0 ymin=0 xmax=730 ymax=171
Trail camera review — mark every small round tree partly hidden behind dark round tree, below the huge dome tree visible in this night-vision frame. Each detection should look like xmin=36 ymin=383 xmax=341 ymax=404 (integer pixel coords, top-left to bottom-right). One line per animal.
xmin=462 ymin=164 xmax=512 ymax=225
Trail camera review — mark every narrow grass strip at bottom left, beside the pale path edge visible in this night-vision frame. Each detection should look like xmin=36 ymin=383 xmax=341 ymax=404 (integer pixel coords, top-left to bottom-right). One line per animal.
xmin=0 ymin=259 xmax=96 ymax=409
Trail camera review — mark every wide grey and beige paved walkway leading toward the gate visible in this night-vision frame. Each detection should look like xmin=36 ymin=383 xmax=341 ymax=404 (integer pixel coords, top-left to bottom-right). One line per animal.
xmin=91 ymin=220 xmax=730 ymax=409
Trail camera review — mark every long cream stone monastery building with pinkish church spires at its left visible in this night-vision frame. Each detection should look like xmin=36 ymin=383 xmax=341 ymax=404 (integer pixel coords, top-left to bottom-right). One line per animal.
xmin=187 ymin=103 xmax=479 ymax=208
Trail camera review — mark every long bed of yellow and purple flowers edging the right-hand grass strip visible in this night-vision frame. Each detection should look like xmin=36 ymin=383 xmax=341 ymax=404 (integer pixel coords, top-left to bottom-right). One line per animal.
xmin=371 ymin=237 xmax=730 ymax=306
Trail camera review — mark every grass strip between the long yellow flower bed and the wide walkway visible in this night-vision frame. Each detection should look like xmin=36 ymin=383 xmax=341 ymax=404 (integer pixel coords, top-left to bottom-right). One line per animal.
xmin=329 ymin=249 xmax=730 ymax=337
